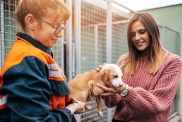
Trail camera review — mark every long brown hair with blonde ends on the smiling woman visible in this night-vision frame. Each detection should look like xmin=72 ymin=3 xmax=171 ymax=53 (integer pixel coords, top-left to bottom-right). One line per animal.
xmin=124 ymin=13 xmax=164 ymax=75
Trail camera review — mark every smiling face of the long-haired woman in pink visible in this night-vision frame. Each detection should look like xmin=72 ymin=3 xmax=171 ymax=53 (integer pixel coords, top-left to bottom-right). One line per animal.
xmin=131 ymin=21 xmax=150 ymax=53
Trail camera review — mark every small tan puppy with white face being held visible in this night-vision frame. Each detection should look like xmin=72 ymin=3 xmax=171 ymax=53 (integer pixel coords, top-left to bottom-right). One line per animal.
xmin=68 ymin=64 xmax=123 ymax=117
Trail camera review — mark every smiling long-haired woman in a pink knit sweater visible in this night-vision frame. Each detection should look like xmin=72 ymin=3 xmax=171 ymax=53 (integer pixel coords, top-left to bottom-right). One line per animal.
xmin=97 ymin=13 xmax=182 ymax=122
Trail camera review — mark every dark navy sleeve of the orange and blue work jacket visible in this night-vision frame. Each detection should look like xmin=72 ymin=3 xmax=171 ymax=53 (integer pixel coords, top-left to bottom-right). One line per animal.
xmin=1 ymin=57 xmax=73 ymax=122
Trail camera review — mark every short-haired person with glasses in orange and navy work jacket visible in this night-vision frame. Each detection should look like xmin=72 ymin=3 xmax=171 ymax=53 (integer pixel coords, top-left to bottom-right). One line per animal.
xmin=0 ymin=0 xmax=85 ymax=122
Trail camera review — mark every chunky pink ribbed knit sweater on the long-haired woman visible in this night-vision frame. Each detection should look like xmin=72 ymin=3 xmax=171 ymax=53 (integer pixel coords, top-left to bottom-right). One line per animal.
xmin=104 ymin=53 xmax=182 ymax=122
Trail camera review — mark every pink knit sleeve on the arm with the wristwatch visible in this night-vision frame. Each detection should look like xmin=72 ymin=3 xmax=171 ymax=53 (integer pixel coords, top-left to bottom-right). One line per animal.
xmin=124 ymin=56 xmax=182 ymax=114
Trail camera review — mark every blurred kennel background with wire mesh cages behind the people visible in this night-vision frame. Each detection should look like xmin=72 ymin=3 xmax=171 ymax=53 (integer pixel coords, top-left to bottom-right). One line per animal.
xmin=0 ymin=0 xmax=182 ymax=122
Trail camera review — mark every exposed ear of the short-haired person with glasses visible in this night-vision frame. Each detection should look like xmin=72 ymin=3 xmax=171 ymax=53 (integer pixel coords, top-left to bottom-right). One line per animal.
xmin=25 ymin=14 xmax=37 ymax=30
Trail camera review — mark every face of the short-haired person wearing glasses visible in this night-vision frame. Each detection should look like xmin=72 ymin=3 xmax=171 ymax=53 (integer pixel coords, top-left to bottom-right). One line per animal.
xmin=33 ymin=11 xmax=63 ymax=48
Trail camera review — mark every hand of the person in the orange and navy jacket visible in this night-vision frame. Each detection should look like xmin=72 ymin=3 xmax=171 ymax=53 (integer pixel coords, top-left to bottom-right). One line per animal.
xmin=66 ymin=101 xmax=85 ymax=114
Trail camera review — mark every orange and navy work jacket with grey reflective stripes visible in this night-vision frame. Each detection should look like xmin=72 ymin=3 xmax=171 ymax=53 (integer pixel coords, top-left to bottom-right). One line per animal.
xmin=0 ymin=33 xmax=75 ymax=122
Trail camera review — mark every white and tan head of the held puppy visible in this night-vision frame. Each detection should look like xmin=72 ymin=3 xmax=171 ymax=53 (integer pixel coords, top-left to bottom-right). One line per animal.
xmin=99 ymin=64 xmax=123 ymax=87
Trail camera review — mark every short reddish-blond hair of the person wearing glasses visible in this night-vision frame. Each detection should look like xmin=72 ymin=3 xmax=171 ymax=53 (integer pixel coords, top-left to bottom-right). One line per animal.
xmin=14 ymin=0 xmax=70 ymax=30
